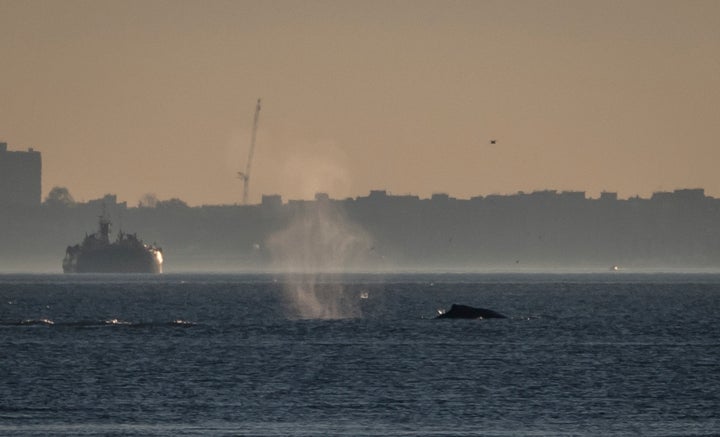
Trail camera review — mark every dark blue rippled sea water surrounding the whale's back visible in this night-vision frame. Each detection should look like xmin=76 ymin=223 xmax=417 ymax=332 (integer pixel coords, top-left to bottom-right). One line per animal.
xmin=0 ymin=274 xmax=720 ymax=436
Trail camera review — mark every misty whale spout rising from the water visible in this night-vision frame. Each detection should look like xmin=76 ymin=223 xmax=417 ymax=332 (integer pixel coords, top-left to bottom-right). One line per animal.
xmin=267 ymin=201 xmax=373 ymax=319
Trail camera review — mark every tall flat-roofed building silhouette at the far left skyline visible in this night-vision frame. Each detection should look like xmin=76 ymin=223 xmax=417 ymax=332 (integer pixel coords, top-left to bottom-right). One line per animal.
xmin=0 ymin=143 xmax=42 ymax=206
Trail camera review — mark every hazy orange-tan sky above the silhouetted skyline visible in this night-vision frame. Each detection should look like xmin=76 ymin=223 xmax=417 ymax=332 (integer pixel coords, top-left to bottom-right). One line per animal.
xmin=0 ymin=0 xmax=720 ymax=205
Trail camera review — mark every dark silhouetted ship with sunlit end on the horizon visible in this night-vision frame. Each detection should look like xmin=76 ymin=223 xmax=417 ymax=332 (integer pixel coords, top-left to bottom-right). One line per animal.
xmin=63 ymin=213 xmax=163 ymax=273
